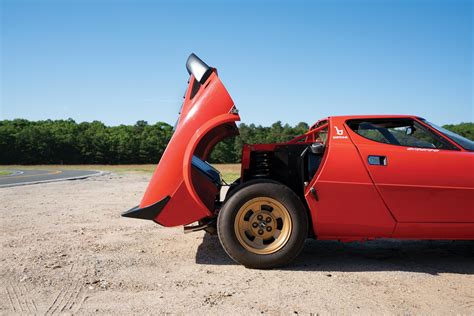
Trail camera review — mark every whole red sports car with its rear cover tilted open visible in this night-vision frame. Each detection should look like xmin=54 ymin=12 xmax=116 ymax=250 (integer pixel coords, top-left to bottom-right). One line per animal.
xmin=123 ymin=54 xmax=474 ymax=268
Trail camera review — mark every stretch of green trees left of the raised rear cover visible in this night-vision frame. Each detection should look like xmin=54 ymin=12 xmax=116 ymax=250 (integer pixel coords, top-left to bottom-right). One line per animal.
xmin=0 ymin=119 xmax=173 ymax=164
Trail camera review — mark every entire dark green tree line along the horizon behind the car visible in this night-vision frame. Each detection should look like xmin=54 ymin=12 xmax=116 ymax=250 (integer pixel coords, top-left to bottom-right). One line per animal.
xmin=0 ymin=119 xmax=474 ymax=165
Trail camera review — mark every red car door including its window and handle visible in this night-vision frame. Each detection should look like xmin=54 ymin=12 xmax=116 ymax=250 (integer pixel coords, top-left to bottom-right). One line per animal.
xmin=347 ymin=117 xmax=474 ymax=223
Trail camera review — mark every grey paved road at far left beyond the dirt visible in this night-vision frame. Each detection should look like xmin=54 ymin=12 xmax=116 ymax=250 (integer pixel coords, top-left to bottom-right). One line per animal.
xmin=0 ymin=170 xmax=101 ymax=188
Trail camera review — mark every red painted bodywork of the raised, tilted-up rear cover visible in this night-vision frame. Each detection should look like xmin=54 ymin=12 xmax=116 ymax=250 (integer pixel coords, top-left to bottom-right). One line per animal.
xmin=140 ymin=72 xmax=240 ymax=227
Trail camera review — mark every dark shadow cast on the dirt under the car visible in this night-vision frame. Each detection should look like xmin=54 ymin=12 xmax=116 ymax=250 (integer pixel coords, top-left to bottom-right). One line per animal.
xmin=196 ymin=234 xmax=474 ymax=275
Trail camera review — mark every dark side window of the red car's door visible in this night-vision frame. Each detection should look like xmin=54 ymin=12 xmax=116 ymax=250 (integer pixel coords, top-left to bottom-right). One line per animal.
xmin=347 ymin=119 xmax=459 ymax=150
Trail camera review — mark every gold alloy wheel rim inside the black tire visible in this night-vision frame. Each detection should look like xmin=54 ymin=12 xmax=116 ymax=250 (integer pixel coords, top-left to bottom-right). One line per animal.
xmin=234 ymin=197 xmax=293 ymax=255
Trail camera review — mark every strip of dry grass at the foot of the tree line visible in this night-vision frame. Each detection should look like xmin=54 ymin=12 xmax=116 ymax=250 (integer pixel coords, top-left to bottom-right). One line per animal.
xmin=0 ymin=164 xmax=240 ymax=183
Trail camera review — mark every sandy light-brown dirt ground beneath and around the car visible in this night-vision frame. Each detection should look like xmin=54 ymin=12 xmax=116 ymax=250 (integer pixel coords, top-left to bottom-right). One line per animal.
xmin=0 ymin=174 xmax=474 ymax=315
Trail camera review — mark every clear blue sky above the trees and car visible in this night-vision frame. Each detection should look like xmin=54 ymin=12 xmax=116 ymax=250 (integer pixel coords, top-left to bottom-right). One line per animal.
xmin=0 ymin=0 xmax=474 ymax=125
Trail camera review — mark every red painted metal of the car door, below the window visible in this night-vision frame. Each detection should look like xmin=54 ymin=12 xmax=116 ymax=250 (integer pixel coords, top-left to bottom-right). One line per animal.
xmin=351 ymin=137 xmax=474 ymax=223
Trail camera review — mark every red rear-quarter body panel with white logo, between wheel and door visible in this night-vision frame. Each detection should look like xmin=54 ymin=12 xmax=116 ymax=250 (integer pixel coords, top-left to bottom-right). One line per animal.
xmin=306 ymin=119 xmax=395 ymax=239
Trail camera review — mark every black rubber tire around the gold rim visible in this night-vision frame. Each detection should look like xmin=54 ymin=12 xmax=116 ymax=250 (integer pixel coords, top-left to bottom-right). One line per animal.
xmin=217 ymin=180 xmax=308 ymax=269
